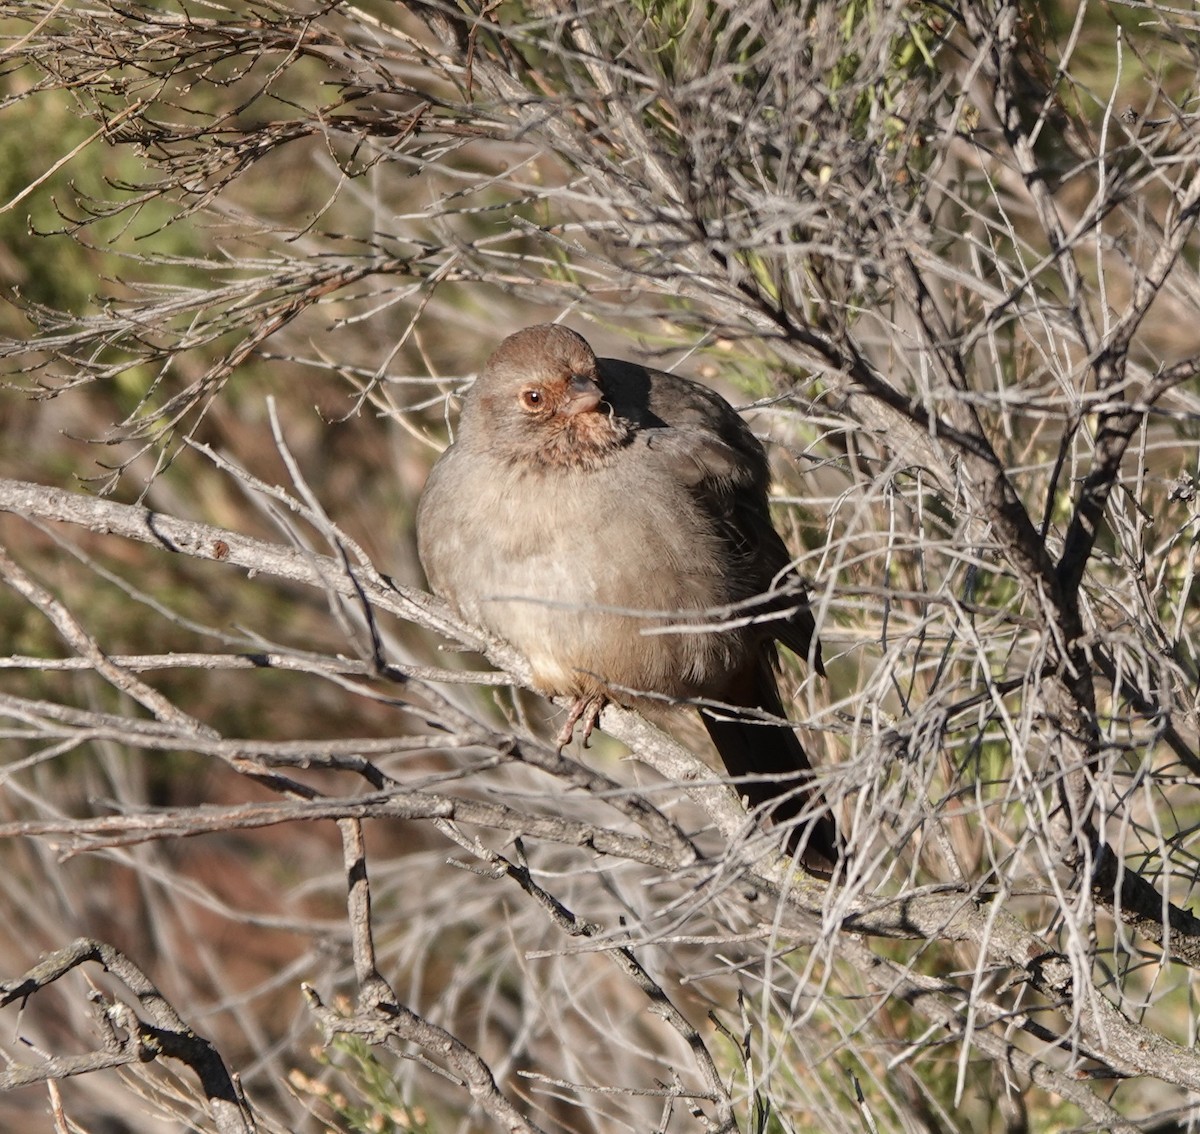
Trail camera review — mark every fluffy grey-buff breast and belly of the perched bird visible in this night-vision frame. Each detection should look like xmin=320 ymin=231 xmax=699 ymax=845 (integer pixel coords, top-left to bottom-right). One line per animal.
xmin=419 ymin=451 xmax=745 ymax=697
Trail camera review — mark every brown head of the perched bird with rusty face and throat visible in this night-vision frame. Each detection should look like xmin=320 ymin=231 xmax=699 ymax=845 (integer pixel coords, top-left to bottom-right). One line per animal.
xmin=461 ymin=323 xmax=630 ymax=468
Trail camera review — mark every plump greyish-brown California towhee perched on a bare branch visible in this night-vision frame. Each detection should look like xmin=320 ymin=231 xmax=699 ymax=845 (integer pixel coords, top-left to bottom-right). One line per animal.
xmin=416 ymin=324 xmax=838 ymax=862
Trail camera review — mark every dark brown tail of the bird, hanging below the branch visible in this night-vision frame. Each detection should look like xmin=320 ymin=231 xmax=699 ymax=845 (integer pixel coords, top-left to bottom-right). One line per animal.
xmin=700 ymin=659 xmax=840 ymax=869
